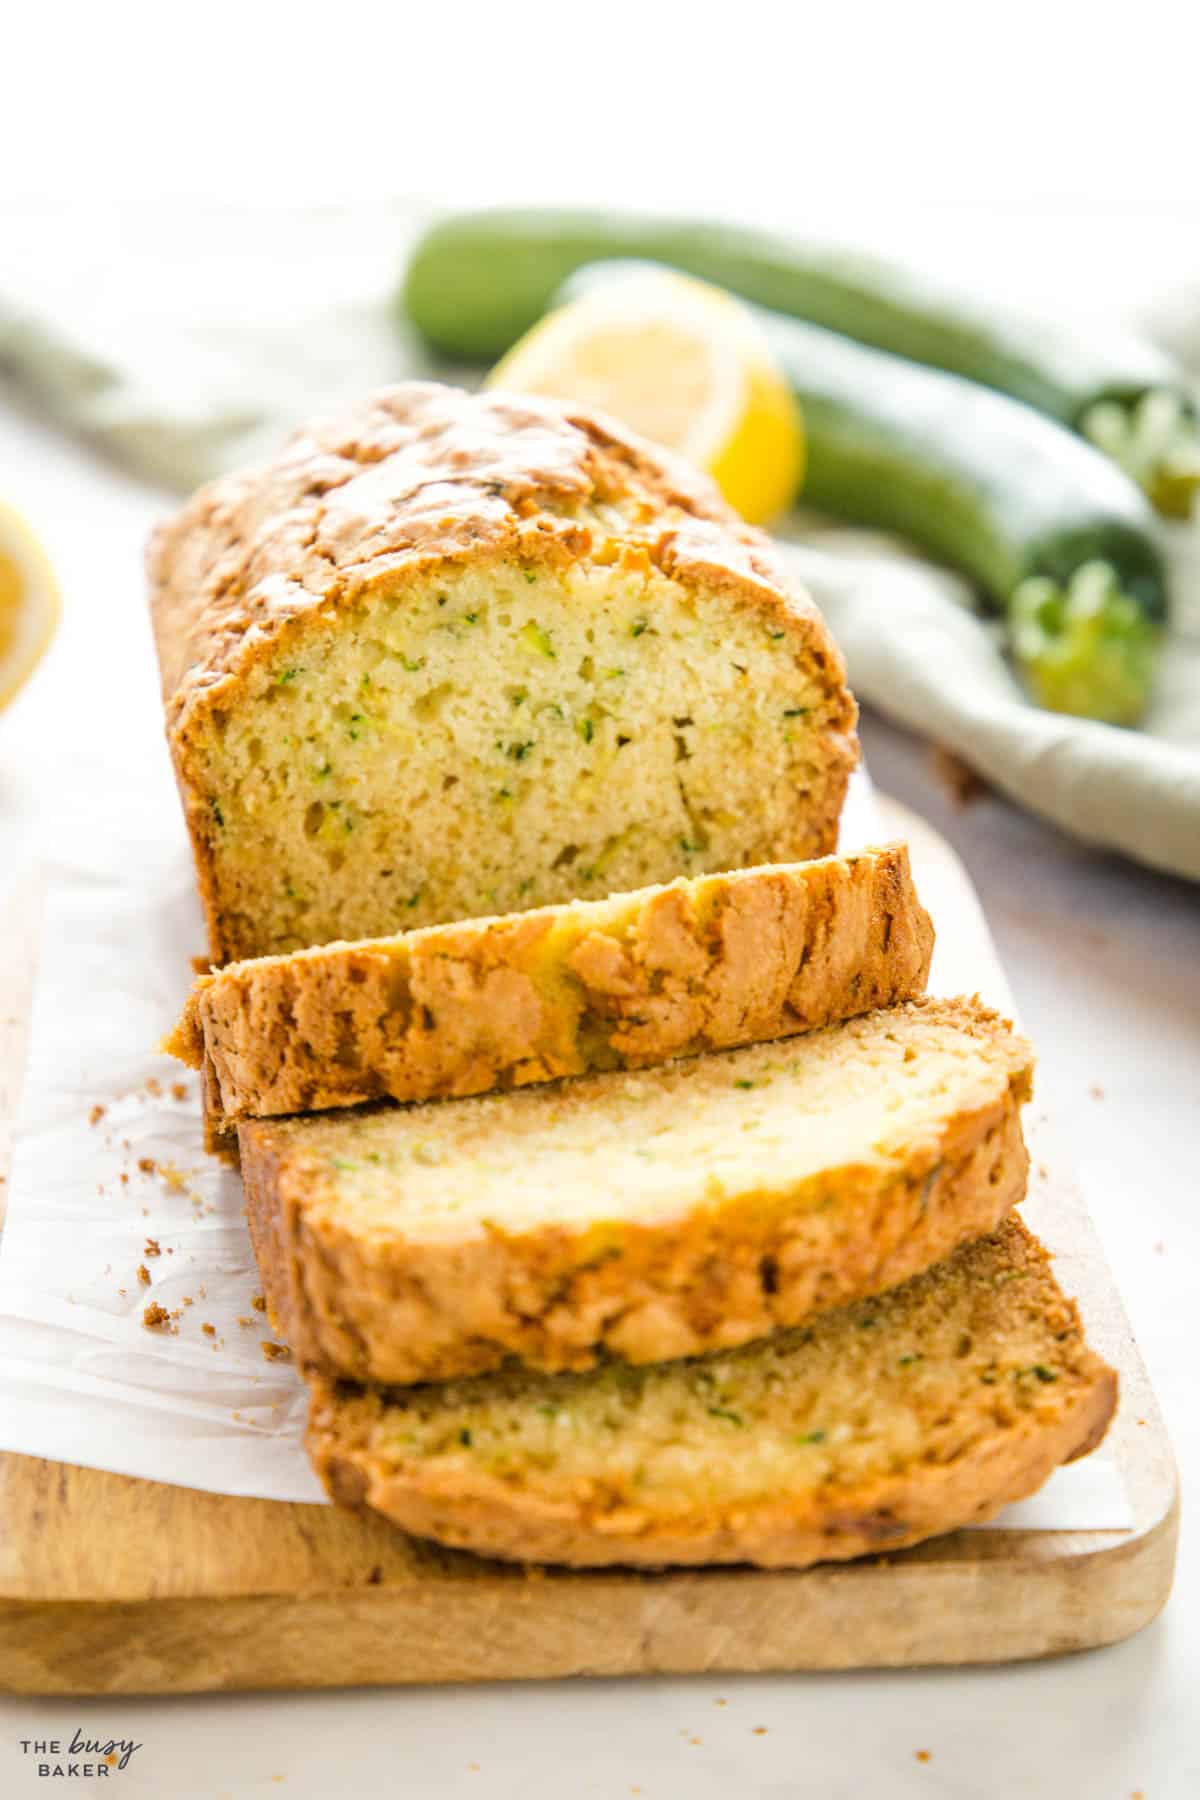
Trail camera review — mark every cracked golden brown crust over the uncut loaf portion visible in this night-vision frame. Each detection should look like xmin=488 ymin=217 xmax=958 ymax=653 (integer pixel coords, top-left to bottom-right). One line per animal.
xmin=148 ymin=382 xmax=856 ymax=963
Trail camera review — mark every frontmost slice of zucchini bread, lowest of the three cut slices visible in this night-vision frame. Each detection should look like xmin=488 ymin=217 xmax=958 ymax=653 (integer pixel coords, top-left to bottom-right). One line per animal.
xmin=308 ymin=1219 xmax=1117 ymax=1568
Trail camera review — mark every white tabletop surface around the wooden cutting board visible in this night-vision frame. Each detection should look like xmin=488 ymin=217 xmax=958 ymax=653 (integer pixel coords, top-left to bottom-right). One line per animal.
xmin=0 ymin=354 xmax=1200 ymax=1800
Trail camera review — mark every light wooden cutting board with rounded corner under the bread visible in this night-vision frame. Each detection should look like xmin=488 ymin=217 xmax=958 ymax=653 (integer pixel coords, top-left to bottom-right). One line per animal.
xmin=0 ymin=801 xmax=1178 ymax=1694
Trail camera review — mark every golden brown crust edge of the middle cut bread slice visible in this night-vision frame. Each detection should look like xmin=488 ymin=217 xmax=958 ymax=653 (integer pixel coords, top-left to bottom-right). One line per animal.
xmin=239 ymin=1001 xmax=1031 ymax=1382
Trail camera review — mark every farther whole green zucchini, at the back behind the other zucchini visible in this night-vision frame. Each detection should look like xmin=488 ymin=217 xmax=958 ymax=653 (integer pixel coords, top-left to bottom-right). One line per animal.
xmin=403 ymin=209 xmax=1200 ymax=518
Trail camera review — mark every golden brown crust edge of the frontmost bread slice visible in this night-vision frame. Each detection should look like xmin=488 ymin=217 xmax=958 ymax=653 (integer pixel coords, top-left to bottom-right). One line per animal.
xmin=308 ymin=1219 xmax=1117 ymax=1568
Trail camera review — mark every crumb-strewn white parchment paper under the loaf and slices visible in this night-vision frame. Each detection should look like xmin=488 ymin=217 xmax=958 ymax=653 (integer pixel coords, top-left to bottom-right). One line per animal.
xmin=0 ymin=778 xmax=1133 ymax=1530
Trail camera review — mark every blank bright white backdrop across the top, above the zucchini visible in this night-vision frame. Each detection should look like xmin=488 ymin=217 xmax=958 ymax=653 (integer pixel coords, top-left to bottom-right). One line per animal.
xmin=0 ymin=0 xmax=1198 ymax=216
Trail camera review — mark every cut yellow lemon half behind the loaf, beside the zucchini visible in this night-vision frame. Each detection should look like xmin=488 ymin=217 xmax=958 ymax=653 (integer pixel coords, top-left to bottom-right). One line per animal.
xmin=488 ymin=270 xmax=804 ymax=524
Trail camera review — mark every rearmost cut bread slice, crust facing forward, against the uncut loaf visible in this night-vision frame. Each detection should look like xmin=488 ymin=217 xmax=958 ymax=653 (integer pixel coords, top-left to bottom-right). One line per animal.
xmin=164 ymin=844 xmax=934 ymax=1123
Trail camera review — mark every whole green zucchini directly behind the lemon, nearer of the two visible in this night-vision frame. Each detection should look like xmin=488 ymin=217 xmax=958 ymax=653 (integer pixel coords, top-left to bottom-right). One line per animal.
xmin=551 ymin=263 xmax=1166 ymax=725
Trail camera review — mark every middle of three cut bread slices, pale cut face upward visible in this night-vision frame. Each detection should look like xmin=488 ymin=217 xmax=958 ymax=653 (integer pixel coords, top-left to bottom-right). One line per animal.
xmin=237 ymin=1001 xmax=1031 ymax=1382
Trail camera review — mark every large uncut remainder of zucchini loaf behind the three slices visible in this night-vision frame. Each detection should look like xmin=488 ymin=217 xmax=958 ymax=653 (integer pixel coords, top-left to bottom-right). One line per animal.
xmin=149 ymin=383 xmax=856 ymax=963
